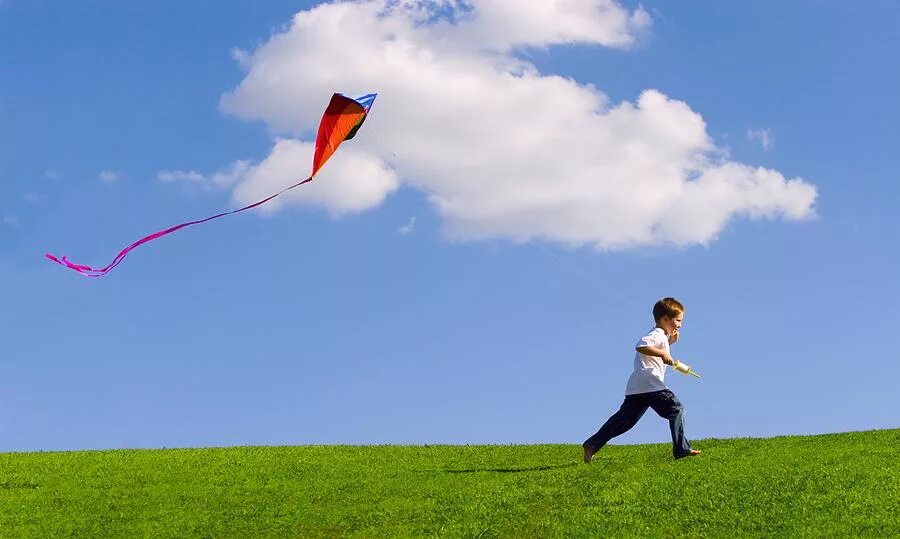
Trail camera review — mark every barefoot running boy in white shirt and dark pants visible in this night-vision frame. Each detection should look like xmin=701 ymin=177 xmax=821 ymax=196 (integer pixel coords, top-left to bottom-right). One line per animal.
xmin=581 ymin=298 xmax=700 ymax=463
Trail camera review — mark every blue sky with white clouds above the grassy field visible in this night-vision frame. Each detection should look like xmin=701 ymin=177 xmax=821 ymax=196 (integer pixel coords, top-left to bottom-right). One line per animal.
xmin=0 ymin=0 xmax=900 ymax=451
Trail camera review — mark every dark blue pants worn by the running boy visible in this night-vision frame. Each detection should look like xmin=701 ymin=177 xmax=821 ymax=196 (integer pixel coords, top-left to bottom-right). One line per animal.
xmin=581 ymin=389 xmax=691 ymax=459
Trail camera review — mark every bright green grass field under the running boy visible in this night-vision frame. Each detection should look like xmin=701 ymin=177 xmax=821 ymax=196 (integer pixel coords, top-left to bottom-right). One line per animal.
xmin=0 ymin=429 xmax=900 ymax=537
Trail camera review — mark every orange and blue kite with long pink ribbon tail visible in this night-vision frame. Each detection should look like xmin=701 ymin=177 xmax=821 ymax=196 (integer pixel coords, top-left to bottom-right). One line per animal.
xmin=44 ymin=94 xmax=377 ymax=277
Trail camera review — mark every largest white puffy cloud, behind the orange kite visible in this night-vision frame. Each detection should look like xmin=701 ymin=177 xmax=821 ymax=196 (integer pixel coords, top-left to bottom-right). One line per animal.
xmin=221 ymin=0 xmax=816 ymax=249
